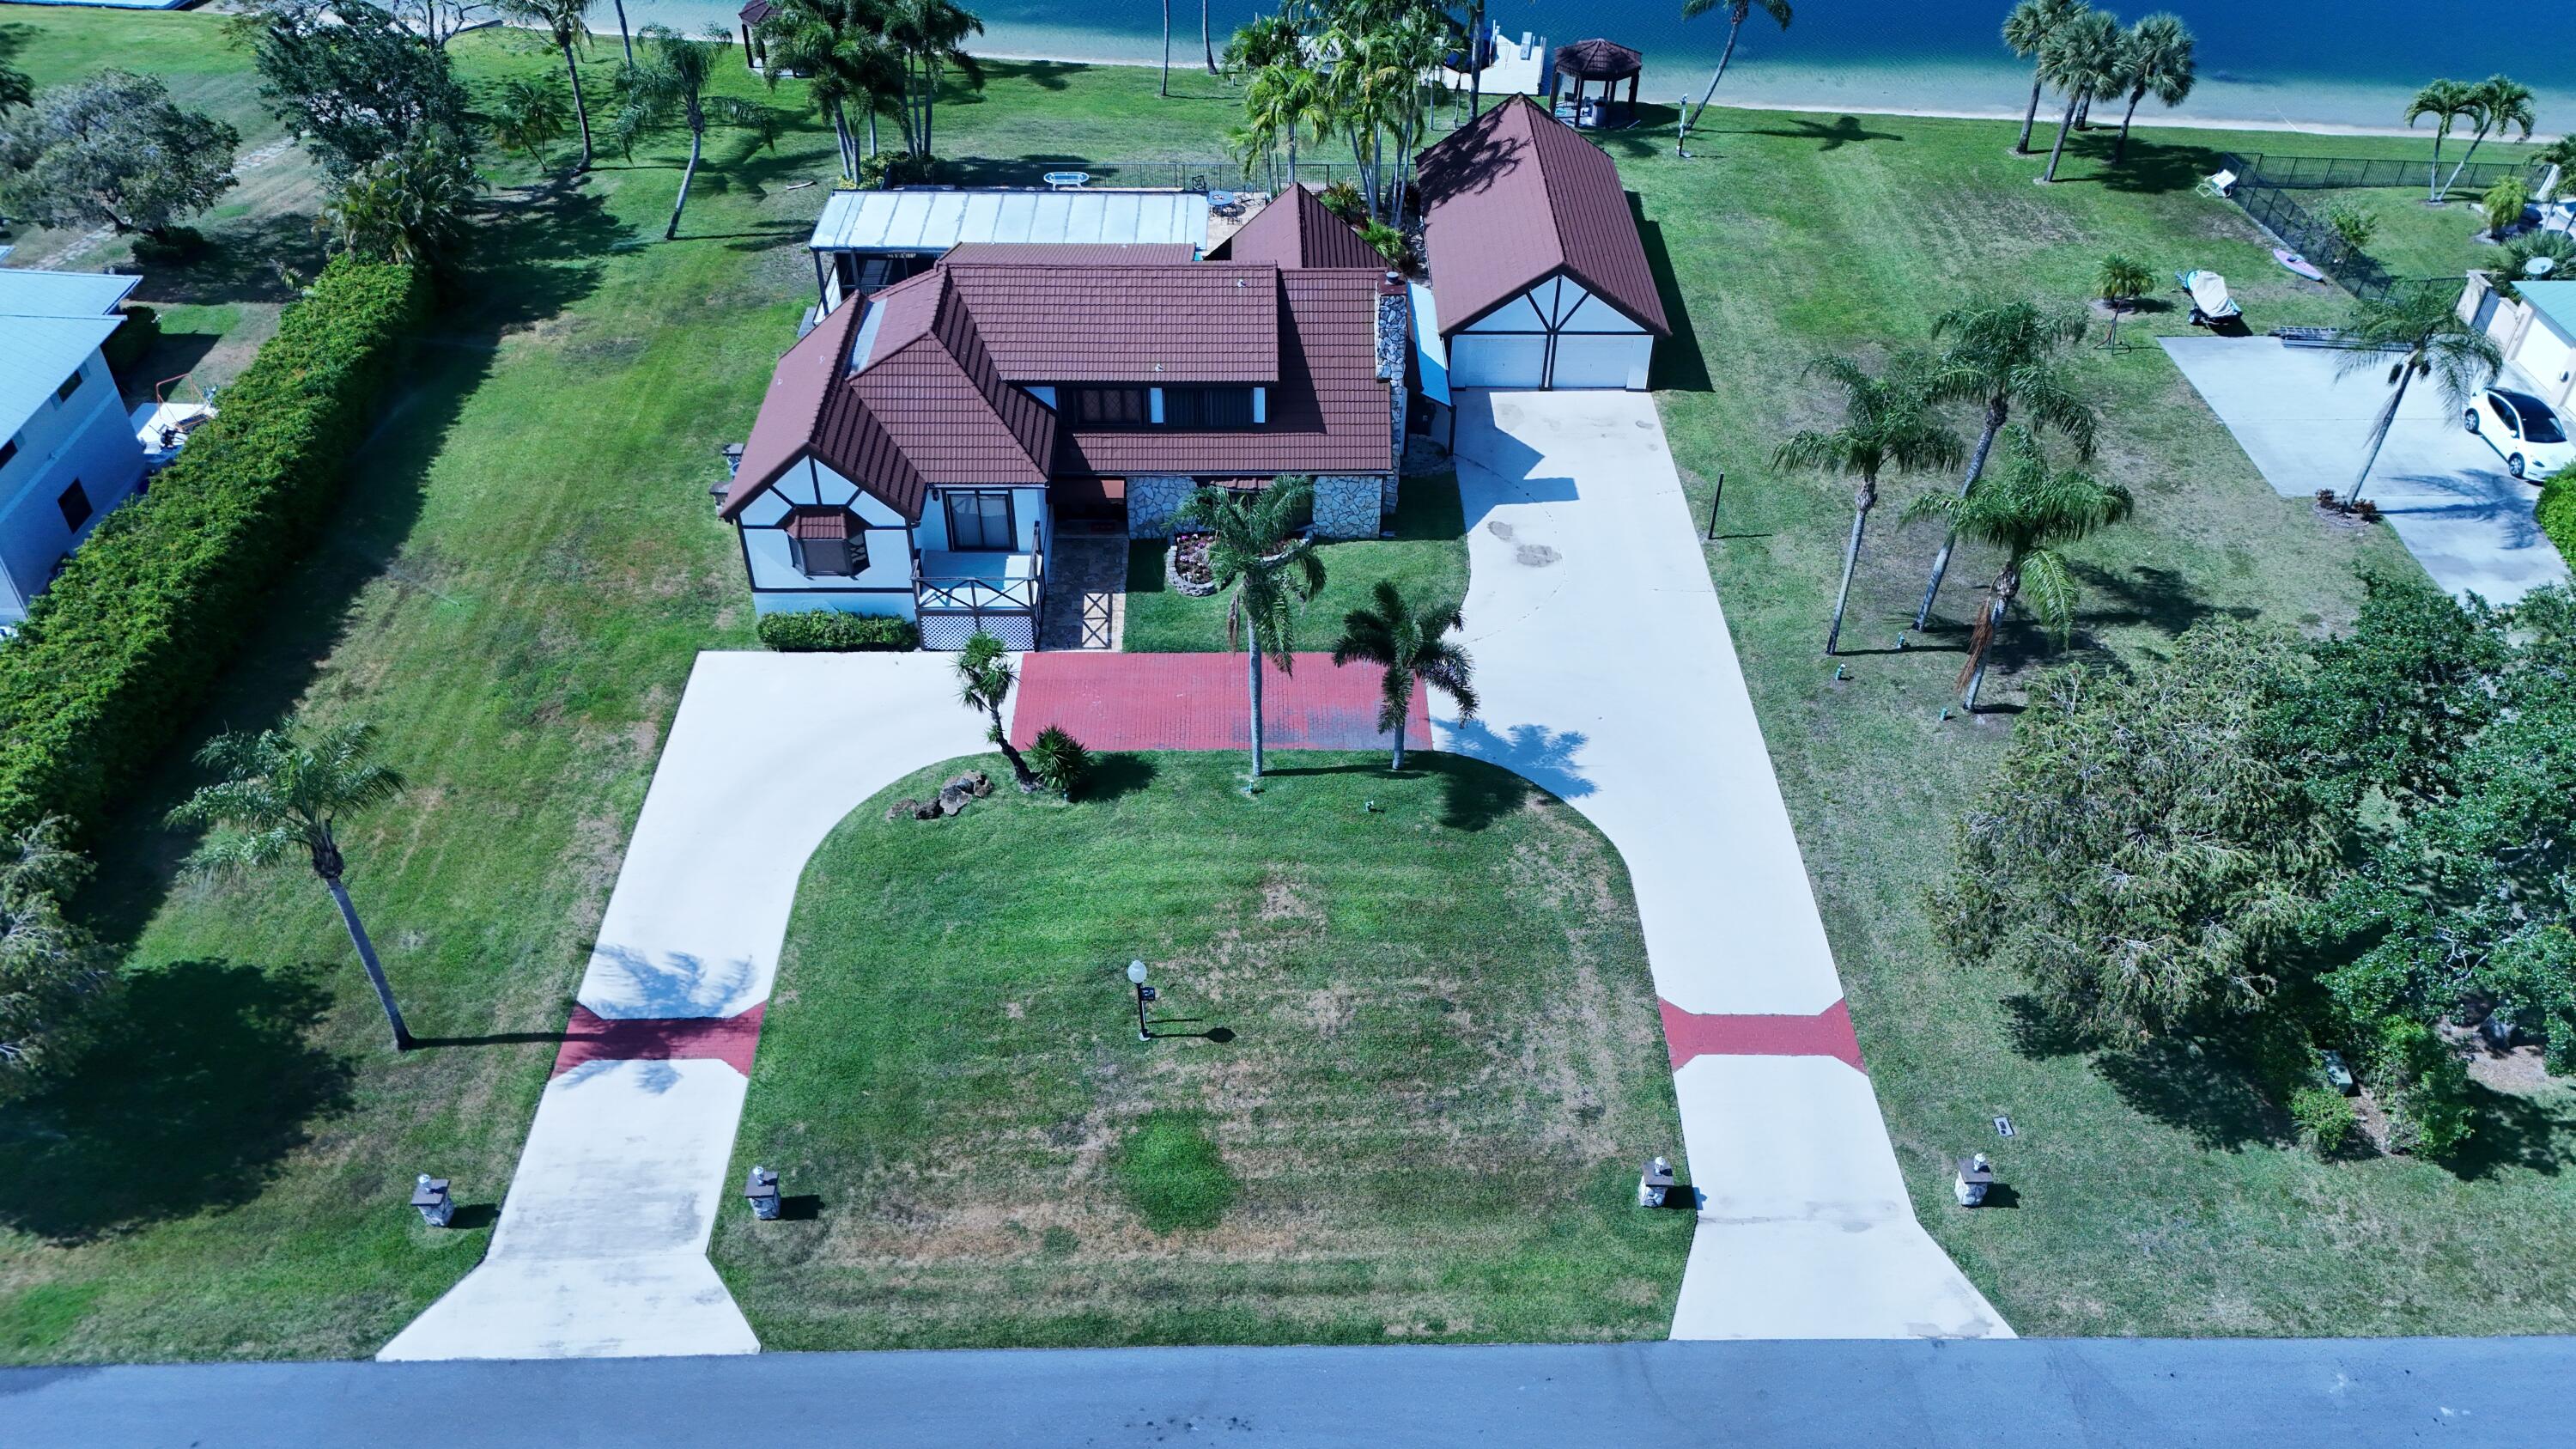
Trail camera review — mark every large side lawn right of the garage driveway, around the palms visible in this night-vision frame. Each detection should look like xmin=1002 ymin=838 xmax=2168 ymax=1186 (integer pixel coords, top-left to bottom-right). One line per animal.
xmin=1615 ymin=113 xmax=2576 ymax=1333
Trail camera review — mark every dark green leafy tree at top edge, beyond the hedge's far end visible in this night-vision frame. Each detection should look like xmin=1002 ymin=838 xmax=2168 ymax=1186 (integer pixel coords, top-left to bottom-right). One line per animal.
xmin=227 ymin=0 xmax=471 ymax=183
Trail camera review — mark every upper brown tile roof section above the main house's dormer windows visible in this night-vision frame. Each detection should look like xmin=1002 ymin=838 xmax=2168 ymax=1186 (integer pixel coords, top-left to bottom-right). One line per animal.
xmin=943 ymin=263 xmax=1280 ymax=384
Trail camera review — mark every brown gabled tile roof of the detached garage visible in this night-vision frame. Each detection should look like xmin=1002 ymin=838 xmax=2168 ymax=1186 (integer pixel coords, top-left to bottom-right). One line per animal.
xmin=1422 ymin=95 xmax=1672 ymax=338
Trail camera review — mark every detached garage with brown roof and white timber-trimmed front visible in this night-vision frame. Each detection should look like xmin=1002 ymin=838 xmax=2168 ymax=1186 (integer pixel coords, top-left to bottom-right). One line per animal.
xmin=1422 ymin=95 xmax=1672 ymax=399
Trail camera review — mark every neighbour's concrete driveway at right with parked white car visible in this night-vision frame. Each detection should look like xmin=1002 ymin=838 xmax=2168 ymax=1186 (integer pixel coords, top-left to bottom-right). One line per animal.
xmin=2164 ymin=338 xmax=2568 ymax=603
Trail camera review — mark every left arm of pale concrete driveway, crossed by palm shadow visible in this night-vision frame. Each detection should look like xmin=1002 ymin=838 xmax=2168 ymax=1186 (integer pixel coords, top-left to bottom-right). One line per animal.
xmin=379 ymin=652 xmax=987 ymax=1359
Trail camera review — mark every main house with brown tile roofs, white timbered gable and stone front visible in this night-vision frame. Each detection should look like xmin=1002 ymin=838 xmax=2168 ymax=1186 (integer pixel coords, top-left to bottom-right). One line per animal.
xmin=719 ymin=198 xmax=1409 ymax=649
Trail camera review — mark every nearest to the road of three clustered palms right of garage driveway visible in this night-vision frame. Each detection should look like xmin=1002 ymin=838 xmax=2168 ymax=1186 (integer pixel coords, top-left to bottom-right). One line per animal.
xmin=1906 ymin=423 xmax=2136 ymax=711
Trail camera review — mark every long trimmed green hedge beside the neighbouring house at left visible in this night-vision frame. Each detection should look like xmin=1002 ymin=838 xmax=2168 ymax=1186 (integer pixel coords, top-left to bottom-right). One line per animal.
xmin=0 ymin=258 xmax=428 ymax=836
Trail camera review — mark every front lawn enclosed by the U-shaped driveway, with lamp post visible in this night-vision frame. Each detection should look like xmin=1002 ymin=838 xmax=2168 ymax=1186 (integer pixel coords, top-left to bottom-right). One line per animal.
xmin=714 ymin=753 xmax=1692 ymax=1349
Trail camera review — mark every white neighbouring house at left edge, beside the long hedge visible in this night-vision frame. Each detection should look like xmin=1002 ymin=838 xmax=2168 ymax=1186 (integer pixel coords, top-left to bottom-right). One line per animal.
xmin=0 ymin=268 xmax=144 ymax=624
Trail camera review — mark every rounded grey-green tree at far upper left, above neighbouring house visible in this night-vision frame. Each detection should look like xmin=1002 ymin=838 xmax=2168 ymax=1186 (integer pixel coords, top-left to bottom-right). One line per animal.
xmin=0 ymin=70 xmax=242 ymax=240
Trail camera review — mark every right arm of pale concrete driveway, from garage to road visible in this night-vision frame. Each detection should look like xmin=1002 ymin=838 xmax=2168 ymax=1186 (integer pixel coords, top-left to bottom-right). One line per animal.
xmin=1432 ymin=392 xmax=2012 ymax=1338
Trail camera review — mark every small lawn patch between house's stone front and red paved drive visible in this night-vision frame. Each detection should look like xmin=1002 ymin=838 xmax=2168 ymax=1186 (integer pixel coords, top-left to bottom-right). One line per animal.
xmin=1126 ymin=472 xmax=1466 ymax=654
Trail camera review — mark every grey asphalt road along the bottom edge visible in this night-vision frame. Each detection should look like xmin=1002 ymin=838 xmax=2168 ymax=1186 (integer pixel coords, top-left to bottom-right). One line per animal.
xmin=0 ymin=1338 xmax=2576 ymax=1449
